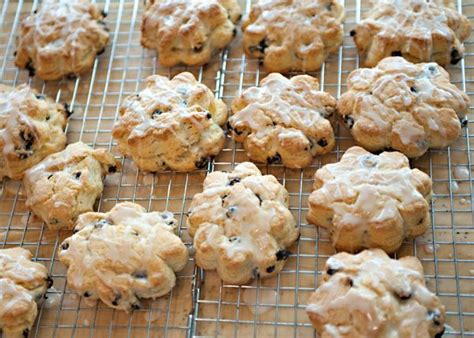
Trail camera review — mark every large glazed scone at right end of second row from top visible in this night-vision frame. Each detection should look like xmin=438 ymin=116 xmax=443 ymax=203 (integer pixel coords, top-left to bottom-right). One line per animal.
xmin=337 ymin=57 xmax=469 ymax=158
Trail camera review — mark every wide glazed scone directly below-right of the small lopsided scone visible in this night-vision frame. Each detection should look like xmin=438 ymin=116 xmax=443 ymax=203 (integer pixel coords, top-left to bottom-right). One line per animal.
xmin=59 ymin=202 xmax=188 ymax=311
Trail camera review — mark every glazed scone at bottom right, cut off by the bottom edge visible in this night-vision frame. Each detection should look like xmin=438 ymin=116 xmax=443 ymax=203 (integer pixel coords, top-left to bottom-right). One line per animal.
xmin=306 ymin=249 xmax=445 ymax=338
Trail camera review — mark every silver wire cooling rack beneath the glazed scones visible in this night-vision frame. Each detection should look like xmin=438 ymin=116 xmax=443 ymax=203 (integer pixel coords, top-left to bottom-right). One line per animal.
xmin=0 ymin=0 xmax=474 ymax=337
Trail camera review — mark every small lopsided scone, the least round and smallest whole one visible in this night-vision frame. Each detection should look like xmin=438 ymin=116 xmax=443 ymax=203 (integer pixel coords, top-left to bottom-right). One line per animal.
xmin=23 ymin=142 xmax=120 ymax=230
